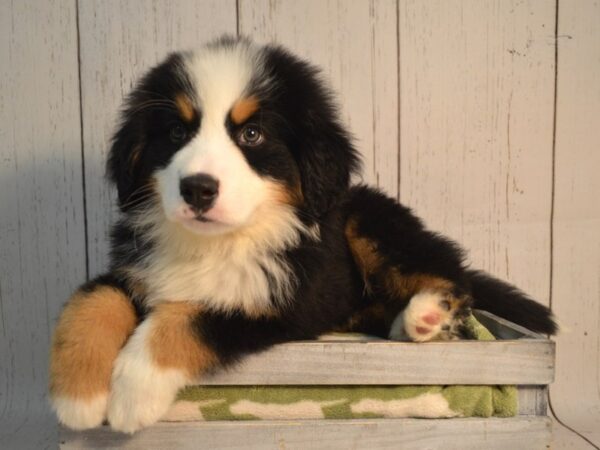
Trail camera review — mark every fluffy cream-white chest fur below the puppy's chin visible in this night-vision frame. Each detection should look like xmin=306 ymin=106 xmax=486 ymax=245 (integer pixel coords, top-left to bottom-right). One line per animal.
xmin=135 ymin=205 xmax=318 ymax=315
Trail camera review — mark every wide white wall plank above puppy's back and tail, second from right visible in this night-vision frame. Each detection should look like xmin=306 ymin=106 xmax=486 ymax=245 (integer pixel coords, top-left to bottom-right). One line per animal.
xmin=399 ymin=0 xmax=555 ymax=304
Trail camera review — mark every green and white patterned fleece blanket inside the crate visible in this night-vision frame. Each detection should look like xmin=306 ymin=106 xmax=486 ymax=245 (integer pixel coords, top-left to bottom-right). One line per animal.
xmin=163 ymin=316 xmax=518 ymax=421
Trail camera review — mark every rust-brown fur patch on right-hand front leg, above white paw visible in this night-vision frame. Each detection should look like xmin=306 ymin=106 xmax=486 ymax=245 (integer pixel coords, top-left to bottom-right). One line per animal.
xmin=149 ymin=302 xmax=217 ymax=377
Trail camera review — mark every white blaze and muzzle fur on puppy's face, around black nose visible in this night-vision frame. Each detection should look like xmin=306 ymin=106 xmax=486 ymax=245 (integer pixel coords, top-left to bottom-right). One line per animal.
xmin=156 ymin=42 xmax=268 ymax=227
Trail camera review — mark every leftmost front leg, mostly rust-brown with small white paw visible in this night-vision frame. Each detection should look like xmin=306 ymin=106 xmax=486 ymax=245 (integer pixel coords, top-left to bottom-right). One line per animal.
xmin=50 ymin=280 xmax=137 ymax=429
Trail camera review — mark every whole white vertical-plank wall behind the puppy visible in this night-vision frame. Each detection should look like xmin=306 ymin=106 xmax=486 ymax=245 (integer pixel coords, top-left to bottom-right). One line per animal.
xmin=0 ymin=0 xmax=600 ymax=445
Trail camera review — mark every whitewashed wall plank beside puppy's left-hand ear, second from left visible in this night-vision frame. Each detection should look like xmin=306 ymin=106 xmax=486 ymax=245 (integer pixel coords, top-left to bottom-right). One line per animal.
xmin=79 ymin=0 xmax=236 ymax=276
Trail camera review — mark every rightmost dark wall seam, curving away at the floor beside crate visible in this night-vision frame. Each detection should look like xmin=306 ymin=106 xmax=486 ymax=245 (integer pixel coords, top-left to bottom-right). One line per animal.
xmin=548 ymin=0 xmax=600 ymax=449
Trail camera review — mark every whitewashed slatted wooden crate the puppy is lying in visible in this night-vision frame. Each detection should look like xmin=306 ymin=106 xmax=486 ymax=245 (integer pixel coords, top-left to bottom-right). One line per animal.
xmin=60 ymin=311 xmax=554 ymax=450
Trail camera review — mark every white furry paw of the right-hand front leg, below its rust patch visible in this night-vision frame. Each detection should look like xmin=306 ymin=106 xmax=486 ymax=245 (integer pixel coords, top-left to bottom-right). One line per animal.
xmin=108 ymin=347 xmax=185 ymax=433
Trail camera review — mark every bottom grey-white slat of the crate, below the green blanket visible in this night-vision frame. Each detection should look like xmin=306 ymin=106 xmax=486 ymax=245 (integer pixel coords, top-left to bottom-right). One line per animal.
xmin=60 ymin=416 xmax=551 ymax=450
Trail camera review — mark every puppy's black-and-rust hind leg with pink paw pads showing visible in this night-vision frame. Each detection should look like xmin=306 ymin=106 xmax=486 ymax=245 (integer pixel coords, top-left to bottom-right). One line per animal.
xmin=345 ymin=188 xmax=471 ymax=342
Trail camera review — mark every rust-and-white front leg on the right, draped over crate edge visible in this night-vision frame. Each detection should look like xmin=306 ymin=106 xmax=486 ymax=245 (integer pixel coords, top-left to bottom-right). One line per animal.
xmin=108 ymin=302 xmax=217 ymax=433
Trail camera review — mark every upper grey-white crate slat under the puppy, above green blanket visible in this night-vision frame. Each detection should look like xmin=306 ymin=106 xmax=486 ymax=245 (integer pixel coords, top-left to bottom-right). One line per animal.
xmin=199 ymin=339 xmax=554 ymax=385
